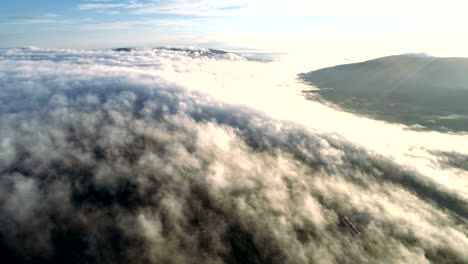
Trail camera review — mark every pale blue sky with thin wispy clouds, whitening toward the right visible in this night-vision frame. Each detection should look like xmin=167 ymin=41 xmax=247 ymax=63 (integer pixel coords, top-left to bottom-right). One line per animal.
xmin=0 ymin=0 xmax=468 ymax=59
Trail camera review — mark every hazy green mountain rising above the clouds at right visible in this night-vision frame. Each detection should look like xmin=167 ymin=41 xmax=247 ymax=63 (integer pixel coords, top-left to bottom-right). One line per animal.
xmin=299 ymin=54 xmax=468 ymax=131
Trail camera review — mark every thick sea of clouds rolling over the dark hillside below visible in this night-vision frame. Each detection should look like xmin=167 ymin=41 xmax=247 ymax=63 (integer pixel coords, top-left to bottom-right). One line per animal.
xmin=0 ymin=47 xmax=468 ymax=263
